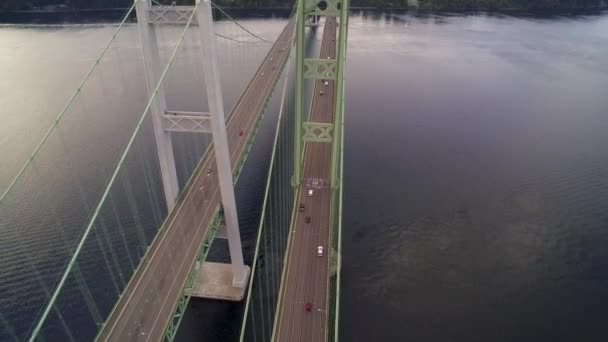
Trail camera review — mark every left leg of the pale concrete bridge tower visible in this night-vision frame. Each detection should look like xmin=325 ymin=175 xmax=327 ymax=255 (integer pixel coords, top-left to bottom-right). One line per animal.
xmin=136 ymin=0 xmax=179 ymax=212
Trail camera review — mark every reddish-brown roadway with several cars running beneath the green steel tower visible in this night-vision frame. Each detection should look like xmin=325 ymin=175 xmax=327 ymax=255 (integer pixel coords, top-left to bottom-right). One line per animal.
xmin=275 ymin=17 xmax=337 ymax=342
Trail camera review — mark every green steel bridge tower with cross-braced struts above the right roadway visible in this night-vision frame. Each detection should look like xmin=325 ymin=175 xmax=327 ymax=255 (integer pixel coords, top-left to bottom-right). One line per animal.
xmin=292 ymin=0 xmax=349 ymax=342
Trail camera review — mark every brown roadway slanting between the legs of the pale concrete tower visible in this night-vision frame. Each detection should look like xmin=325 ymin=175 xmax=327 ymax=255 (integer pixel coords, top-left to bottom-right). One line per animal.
xmin=99 ymin=17 xmax=295 ymax=341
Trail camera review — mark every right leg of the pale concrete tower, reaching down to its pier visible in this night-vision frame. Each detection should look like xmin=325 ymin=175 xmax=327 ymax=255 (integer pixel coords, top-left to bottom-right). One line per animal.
xmin=196 ymin=0 xmax=250 ymax=293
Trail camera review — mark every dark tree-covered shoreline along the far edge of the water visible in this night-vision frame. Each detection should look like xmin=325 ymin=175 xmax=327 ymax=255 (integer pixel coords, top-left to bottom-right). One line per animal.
xmin=0 ymin=0 xmax=608 ymax=10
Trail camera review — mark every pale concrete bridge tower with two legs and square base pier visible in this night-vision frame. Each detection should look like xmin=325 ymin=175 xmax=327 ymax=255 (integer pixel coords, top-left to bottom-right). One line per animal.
xmin=136 ymin=0 xmax=250 ymax=300
